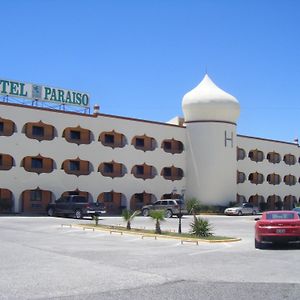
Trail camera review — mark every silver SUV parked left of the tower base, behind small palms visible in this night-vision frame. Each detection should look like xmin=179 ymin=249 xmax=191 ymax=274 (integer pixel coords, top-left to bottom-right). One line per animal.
xmin=142 ymin=199 xmax=187 ymax=218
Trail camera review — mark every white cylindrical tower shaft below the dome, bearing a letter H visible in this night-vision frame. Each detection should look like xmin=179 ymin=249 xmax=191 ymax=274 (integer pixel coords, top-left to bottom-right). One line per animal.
xmin=186 ymin=122 xmax=237 ymax=206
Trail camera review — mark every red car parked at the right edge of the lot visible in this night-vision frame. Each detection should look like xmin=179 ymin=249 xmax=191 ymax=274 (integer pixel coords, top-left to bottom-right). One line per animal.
xmin=255 ymin=210 xmax=300 ymax=249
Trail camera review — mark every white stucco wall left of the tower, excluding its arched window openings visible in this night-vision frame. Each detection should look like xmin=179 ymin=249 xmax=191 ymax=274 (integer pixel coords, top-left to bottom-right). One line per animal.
xmin=0 ymin=104 xmax=186 ymax=212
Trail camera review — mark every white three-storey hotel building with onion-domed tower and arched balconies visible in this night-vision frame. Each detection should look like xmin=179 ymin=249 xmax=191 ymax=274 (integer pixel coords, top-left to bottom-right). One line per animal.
xmin=0 ymin=75 xmax=300 ymax=213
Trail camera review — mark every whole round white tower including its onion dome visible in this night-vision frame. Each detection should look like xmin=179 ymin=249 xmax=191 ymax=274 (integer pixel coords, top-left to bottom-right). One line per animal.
xmin=182 ymin=75 xmax=240 ymax=206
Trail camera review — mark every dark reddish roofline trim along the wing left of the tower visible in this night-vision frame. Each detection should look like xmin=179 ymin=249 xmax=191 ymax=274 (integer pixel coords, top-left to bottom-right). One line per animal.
xmin=0 ymin=101 xmax=185 ymax=128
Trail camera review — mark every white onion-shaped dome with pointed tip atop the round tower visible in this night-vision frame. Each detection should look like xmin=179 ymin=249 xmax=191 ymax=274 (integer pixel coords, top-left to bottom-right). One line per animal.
xmin=182 ymin=74 xmax=240 ymax=123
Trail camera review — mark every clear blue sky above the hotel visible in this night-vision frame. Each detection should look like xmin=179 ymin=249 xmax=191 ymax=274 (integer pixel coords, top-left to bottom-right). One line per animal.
xmin=0 ymin=0 xmax=300 ymax=141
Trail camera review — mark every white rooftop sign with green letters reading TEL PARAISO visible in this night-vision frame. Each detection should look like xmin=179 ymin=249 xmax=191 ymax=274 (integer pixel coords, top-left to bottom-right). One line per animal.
xmin=0 ymin=79 xmax=90 ymax=107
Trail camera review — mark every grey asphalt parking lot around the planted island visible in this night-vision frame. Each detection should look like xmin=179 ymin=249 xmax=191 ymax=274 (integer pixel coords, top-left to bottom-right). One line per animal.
xmin=0 ymin=216 xmax=300 ymax=299
